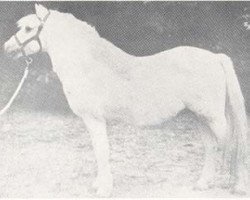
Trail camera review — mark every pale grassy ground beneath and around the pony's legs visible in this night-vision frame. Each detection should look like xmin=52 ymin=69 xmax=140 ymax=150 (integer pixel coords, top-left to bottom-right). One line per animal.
xmin=0 ymin=112 xmax=250 ymax=198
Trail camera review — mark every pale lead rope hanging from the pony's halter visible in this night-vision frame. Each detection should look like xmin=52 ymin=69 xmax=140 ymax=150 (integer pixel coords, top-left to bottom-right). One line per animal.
xmin=0 ymin=57 xmax=33 ymax=116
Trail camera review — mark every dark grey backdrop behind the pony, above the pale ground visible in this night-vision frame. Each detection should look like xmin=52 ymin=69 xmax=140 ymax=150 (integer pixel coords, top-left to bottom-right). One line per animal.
xmin=0 ymin=2 xmax=250 ymax=113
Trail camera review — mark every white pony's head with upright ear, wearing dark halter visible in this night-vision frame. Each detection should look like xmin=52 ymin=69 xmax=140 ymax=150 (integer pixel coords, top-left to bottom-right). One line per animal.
xmin=4 ymin=4 xmax=50 ymax=59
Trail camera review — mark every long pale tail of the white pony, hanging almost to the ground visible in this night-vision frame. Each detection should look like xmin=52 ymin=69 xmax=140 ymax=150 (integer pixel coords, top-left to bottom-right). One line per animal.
xmin=219 ymin=54 xmax=248 ymax=191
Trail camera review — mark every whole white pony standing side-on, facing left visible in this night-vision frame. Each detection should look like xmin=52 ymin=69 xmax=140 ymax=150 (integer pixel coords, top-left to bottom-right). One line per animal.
xmin=4 ymin=5 xmax=248 ymax=196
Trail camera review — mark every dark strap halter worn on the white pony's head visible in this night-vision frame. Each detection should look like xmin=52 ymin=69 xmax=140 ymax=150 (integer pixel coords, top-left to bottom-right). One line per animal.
xmin=14 ymin=11 xmax=50 ymax=57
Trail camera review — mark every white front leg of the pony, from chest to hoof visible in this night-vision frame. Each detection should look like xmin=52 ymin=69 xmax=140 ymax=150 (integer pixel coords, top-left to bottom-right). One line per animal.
xmin=83 ymin=115 xmax=113 ymax=197
